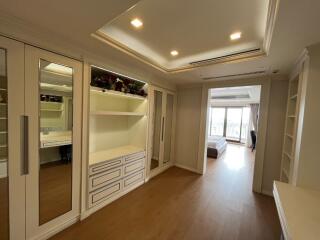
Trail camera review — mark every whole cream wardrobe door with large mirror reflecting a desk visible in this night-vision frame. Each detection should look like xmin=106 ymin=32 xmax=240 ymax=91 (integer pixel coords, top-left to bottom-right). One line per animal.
xmin=25 ymin=46 xmax=82 ymax=239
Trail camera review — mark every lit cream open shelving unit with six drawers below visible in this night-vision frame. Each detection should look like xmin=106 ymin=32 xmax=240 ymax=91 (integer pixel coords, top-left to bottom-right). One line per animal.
xmin=87 ymin=67 xmax=148 ymax=211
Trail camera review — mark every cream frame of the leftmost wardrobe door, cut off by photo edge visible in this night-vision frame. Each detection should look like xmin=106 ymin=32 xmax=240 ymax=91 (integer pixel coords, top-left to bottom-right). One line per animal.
xmin=0 ymin=36 xmax=26 ymax=239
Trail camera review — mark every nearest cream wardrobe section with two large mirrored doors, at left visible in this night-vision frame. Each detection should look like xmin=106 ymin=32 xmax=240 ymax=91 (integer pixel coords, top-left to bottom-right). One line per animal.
xmin=0 ymin=37 xmax=82 ymax=240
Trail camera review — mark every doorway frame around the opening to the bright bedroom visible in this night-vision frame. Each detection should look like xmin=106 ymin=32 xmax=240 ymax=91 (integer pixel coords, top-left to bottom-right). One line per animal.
xmin=197 ymin=76 xmax=271 ymax=193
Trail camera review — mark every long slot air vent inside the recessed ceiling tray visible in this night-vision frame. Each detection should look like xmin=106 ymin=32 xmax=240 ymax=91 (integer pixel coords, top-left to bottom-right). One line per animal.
xmin=189 ymin=48 xmax=262 ymax=65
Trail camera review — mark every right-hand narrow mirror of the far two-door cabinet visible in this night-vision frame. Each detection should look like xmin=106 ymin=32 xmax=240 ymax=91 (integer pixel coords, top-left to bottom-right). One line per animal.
xmin=163 ymin=93 xmax=174 ymax=163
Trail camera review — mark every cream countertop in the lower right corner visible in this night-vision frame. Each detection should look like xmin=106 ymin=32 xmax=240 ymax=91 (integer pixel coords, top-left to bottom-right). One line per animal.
xmin=273 ymin=181 xmax=320 ymax=240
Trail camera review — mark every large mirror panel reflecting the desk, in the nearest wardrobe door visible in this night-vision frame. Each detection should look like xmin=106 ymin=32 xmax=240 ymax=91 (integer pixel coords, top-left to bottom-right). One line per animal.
xmin=39 ymin=59 xmax=73 ymax=225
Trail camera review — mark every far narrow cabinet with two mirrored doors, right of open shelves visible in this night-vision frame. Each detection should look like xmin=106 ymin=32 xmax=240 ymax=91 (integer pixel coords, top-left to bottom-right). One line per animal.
xmin=148 ymin=86 xmax=176 ymax=177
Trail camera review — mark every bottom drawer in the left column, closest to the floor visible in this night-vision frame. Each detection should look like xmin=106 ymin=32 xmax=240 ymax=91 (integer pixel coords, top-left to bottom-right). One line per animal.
xmin=89 ymin=181 xmax=122 ymax=207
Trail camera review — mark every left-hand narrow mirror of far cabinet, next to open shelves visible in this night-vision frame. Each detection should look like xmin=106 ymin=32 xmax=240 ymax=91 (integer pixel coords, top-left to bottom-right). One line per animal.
xmin=150 ymin=91 xmax=162 ymax=170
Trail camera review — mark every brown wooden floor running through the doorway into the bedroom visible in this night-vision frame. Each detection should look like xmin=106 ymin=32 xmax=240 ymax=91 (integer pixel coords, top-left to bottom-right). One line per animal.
xmin=52 ymin=145 xmax=280 ymax=240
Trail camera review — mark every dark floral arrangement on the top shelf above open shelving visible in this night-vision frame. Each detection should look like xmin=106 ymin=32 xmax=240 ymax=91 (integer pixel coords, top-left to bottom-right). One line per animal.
xmin=90 ymin=67 xmax=147 ymax=97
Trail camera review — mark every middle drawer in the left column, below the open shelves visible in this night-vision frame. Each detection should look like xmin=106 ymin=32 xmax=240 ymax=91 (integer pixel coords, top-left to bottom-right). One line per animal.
xmin=89 ymin=166 xmax=123 ymax=192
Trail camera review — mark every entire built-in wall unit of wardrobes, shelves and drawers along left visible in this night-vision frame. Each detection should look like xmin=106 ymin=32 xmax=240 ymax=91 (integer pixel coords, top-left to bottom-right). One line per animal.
xmin=0 ymin=33 xmax=176 ymax=240
